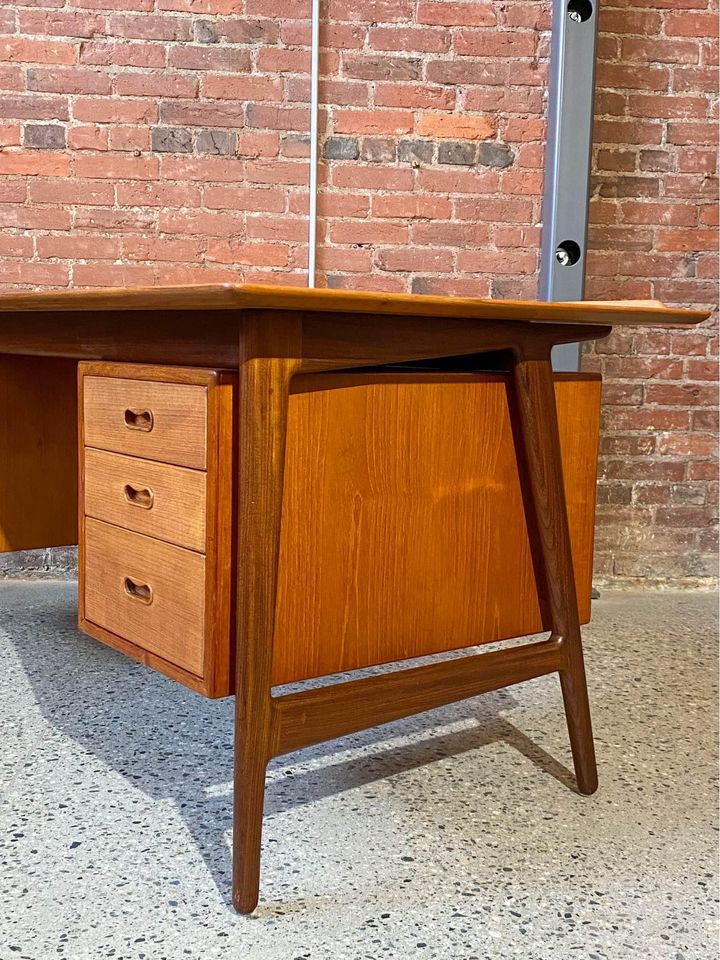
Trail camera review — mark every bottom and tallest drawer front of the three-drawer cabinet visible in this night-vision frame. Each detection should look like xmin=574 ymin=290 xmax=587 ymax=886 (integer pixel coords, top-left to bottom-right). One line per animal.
xmin=83 ymin=518 xmax=205 ymax=676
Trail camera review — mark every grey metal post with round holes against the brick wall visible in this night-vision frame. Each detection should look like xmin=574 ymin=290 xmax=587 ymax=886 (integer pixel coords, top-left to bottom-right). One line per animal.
xmin=539 ymin=0 xmax=598 ymax=370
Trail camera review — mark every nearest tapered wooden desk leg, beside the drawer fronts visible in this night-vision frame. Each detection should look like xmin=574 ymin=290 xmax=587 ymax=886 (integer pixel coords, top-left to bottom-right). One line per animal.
xmin=233 ymin=333 xmax=297 ymax=913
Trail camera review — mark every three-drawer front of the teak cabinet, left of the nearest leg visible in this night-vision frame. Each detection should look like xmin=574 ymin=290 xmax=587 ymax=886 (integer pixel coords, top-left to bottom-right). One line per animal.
xmin=78 ymin=360 xmax=236 ymax=697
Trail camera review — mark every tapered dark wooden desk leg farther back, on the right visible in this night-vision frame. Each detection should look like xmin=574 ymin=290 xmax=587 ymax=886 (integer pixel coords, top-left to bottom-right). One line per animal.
xmin=511 ymin=350 xmax=598 ymax=793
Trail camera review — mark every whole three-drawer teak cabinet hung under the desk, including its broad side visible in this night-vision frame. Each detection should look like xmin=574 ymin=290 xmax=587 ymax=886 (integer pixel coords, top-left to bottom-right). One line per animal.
xmin=78 ymin=363 xmax=601 ymax=697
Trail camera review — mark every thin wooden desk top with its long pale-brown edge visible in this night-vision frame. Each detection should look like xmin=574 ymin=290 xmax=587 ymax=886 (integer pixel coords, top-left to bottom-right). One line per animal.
xmin=0 ymin=284 xmax=710 ymax=327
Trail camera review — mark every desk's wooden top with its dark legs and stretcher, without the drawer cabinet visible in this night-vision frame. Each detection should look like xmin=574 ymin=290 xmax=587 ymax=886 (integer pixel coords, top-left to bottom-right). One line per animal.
xmin=0 ymin=285 xmax=707 ymax=913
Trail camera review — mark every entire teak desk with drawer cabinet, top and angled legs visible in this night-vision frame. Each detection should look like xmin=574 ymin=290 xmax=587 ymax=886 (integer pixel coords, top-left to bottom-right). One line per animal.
xmin=0 ymin=284 xmax=707 ymax=913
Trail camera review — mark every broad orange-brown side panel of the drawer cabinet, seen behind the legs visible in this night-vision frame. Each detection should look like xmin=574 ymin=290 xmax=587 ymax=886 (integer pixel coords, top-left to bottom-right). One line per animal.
xmin=273 ymin=373 xmax=601 ymax=684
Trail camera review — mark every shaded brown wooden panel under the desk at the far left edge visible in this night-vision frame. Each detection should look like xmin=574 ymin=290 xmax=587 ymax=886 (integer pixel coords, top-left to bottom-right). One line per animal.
xmin=0 ymin=355 xmax=78 ymax=553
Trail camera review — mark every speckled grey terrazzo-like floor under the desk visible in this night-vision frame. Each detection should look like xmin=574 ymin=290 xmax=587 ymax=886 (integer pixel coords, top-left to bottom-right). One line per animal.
xmin=0 ymin=582 xmax=718 ymax=960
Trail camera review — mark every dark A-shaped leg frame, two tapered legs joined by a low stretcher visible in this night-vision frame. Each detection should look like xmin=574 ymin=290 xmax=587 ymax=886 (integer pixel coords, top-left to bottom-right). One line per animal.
xmin=233 ymin=311 xmax=609 ymax=913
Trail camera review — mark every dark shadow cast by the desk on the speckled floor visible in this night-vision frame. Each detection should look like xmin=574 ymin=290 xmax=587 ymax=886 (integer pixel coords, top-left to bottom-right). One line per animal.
xmin=2 ymin=584 xmax=575 ymax=903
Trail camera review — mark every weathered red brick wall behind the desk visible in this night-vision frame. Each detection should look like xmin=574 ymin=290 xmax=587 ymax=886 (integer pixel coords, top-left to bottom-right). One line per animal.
xmin=0 ymin=0 xmax=717 ymax=578
